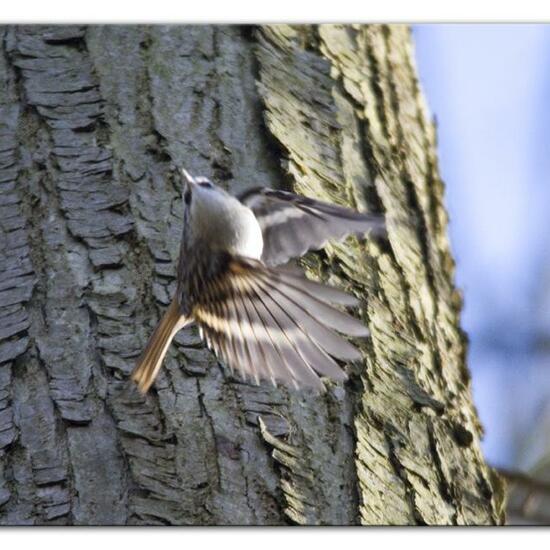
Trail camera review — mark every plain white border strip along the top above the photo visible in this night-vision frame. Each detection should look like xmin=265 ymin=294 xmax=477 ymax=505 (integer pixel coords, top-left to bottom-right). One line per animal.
xmin=0 ymin=0 xmax=550 ymax=23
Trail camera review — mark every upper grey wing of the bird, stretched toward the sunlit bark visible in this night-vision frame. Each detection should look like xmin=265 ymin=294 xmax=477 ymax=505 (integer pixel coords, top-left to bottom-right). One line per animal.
xmin=239 ymin=187 xmax=385 ymax=265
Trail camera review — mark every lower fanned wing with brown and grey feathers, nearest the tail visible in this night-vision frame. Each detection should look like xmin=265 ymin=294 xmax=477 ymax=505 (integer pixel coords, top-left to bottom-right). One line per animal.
xmin=192 ymin=258 xmax=368 ymax=391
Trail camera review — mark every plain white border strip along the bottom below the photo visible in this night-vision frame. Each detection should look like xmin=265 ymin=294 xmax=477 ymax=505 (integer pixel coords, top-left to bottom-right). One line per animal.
xmin=0 ymin=527 xmax=548 ymax=550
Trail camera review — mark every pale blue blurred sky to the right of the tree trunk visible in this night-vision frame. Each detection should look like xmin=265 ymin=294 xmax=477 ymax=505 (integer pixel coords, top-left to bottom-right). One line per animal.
xmin=413 ymin=24 xmax=550 ymax=467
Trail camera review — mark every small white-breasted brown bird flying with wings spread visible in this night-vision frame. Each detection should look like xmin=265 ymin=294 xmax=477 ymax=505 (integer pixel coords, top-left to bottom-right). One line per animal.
xmin=131 ymin=170 xmax=384 ymax=393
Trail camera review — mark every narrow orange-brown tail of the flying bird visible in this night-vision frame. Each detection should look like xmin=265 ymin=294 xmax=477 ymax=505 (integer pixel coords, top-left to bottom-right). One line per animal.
xmin=131 ymin=298 xmax=190 ymax=393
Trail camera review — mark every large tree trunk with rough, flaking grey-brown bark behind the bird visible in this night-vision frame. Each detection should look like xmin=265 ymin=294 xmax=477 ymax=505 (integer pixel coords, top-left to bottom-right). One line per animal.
xmin=0 ymin=25 xmax=503 ymax=525
